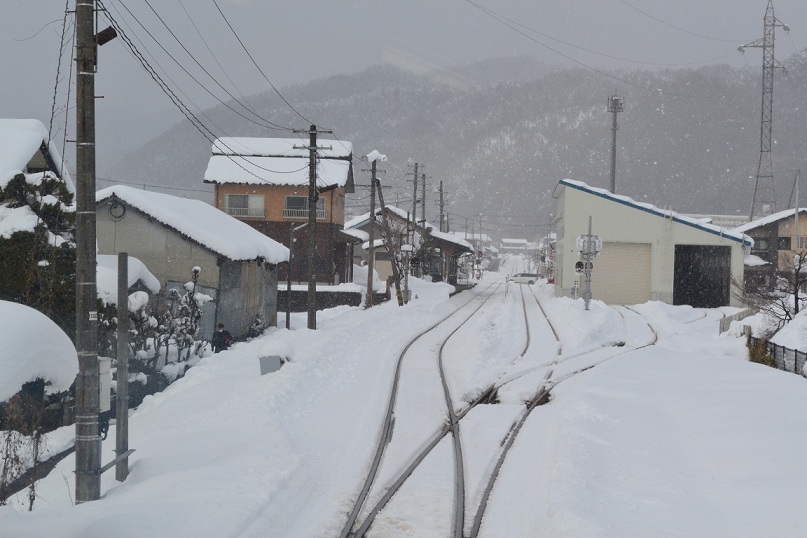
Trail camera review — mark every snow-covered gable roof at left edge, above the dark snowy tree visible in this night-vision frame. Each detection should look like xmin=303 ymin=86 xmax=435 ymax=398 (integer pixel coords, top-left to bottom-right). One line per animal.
xmin=0 ymin=118 xmax=76 ymax=194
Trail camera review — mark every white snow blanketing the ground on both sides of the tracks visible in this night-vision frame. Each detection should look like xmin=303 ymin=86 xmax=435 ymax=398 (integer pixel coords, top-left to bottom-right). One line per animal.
xmin=0 ymin=258 xmax=807 ymax=538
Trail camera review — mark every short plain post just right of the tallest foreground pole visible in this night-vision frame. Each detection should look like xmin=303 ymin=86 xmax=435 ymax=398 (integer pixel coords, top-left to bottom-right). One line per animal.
xmin=115 ymin=252 xmax=129 ymax=482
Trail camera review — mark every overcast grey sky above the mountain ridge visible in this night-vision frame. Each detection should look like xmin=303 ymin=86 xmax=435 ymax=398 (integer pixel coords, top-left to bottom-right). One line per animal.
xmin=0 ymin=0 xmax=807 ymax=172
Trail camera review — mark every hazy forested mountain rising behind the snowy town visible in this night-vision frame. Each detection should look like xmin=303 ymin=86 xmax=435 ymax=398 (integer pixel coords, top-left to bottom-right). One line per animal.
xmin=109 ymin=52 xmax=807 ymax=237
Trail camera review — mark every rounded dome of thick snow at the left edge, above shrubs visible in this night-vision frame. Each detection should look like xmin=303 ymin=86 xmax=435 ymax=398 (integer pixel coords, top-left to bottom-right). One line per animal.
xmin=0 ymin=301 xmax=78 ymax=402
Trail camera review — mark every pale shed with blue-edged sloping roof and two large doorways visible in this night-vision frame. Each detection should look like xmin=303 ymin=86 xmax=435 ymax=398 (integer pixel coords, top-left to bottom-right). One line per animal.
xmin=553 ymin=179 xmax=752 ymax=308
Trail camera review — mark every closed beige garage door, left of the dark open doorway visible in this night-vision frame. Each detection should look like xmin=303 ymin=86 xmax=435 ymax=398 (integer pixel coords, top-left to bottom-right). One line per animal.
xmin=591 ymin=243 xmax=650 ymax=304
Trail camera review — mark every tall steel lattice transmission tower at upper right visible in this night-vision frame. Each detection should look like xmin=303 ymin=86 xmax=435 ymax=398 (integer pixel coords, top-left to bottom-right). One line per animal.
xmin=737 ymin=0 xmax=790 ymax=220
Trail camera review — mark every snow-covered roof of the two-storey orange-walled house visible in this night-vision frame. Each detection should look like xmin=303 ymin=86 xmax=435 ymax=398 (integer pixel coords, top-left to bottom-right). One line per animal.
xmin=204 ymin=137 xmax=353 ymax=187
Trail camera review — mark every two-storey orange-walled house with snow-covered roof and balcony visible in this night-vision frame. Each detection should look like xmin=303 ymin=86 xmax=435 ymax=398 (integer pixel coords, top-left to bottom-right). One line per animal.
xmin=204 ymin=137 xmax=353 ymax=284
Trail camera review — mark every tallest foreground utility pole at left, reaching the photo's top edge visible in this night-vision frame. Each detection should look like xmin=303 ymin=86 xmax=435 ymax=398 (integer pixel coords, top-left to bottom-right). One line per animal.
xmin=76 ymin=0 xmax=101 ymax=504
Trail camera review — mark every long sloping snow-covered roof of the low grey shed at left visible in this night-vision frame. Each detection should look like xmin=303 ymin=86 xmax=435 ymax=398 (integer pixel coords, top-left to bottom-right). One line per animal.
xmin=95 ymin=185 xmax=289 ymax=264
